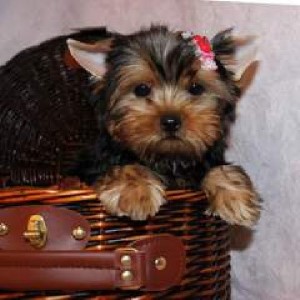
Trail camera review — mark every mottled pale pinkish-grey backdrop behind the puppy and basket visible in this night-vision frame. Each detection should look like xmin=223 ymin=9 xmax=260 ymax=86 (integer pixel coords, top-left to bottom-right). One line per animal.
xmin=0 ymin=0 xmax=300 ymax=300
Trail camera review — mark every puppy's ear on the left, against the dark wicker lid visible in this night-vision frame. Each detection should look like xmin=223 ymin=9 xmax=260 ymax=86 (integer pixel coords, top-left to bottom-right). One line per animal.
xmin=67 ymin=39 xmax=112 ymax=78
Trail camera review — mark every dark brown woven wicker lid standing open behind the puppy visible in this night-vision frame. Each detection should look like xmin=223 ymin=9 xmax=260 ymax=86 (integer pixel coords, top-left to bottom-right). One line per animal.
xmin=0 ymin=37 xmax=96 ymax=185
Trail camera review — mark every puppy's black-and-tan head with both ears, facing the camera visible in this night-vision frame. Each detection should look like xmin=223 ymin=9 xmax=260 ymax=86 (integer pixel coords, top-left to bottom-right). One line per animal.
xmin=68 ymin=26 xmax=254 ymax=159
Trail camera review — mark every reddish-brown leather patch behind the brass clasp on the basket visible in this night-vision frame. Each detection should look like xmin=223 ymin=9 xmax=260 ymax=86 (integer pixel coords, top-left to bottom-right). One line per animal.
xmin=0 ymin=205 xmax=90 ymax=251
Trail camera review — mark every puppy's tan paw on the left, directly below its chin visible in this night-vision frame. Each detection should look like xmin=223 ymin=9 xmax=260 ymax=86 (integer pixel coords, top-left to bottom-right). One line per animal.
xmin=96 ymin=165 xmax=166 ymax=220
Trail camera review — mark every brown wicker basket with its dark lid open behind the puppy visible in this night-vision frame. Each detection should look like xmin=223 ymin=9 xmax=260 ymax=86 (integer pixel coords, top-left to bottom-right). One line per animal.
xmin=0 ymin=34 xmax=230 ymax=300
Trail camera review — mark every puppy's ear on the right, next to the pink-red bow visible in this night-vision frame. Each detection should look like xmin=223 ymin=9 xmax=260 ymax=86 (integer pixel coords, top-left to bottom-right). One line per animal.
xmin=212 ymin=29 xmax=259 ymax=93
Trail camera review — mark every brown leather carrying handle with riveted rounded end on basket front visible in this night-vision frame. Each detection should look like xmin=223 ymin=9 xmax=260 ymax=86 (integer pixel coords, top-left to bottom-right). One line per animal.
xmin=0 ymin=235 xmax=185 ymax=291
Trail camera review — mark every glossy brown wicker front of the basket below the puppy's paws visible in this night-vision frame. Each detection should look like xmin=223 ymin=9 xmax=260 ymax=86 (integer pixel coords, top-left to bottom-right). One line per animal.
xmin=0 ymin=188 xmax=230 ymax=300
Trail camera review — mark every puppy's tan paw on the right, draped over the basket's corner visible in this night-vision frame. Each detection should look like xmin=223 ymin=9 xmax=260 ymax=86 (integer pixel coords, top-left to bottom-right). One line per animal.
xmin=202 ymin=165 xmax=261 ymax=226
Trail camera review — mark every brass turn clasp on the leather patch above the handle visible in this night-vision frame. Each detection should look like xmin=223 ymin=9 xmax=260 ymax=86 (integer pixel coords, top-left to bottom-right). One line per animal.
xmin=23 ymin=215 xmax=48 ymax=249
